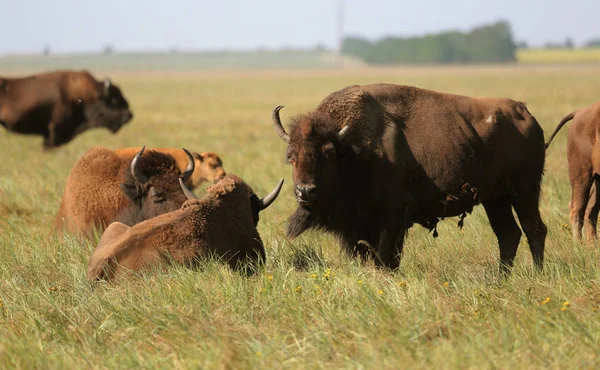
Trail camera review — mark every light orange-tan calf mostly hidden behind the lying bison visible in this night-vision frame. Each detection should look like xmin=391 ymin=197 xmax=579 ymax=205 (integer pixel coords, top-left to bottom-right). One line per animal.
xmin=115 ymin=147 xmax=226 ymax=190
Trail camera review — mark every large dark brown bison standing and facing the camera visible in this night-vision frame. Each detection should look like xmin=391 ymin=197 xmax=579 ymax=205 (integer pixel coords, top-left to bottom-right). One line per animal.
xmin=273 ymin=84 xmax=546 ymax=272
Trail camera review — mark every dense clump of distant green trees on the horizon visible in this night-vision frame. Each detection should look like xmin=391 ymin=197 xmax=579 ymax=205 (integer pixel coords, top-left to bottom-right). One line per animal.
xmin=342 ymin=21 xmax=516 ymax=64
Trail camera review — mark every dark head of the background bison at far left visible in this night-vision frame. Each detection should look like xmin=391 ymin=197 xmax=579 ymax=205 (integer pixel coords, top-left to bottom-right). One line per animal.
xmin=85 ymin=79 xmax=133 ymax=133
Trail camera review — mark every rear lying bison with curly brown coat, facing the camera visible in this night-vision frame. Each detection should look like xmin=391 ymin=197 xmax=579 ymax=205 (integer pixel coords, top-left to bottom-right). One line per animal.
xmin=55 ymin=147 xmax=194 ymax=236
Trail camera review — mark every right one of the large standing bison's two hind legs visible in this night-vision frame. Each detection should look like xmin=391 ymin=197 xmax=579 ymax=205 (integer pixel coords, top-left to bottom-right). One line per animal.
xmin=513 ymin=194 xmax=548 ymax=270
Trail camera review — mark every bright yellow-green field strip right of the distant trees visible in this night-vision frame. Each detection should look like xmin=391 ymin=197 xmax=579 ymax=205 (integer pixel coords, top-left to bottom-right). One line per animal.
xmin=517 ymin=48 xmax=600 ymax=64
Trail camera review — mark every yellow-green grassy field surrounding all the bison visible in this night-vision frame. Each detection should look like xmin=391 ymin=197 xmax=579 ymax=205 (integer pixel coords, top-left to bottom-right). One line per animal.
xmin=0 ymin=66 xmax=600 ymax=369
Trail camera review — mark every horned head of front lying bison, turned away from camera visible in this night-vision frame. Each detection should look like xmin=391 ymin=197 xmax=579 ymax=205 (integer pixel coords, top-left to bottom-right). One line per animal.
xmin=179 ymin=175 xmax=283 ymax=227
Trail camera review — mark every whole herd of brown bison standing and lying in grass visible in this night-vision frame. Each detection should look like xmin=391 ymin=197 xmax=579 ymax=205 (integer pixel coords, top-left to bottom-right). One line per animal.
xmin=0 ymin=71 xmax=600 ymax=281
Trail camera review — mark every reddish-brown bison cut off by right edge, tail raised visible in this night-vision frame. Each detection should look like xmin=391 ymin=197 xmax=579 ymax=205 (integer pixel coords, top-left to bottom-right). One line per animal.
xmin=546 ymin=102 xmax=600 ymax=241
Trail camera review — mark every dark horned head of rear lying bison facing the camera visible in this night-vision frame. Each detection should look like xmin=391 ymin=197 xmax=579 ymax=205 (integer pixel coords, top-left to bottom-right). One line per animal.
xmin=115 ymin=147 xmax=194 ymax=225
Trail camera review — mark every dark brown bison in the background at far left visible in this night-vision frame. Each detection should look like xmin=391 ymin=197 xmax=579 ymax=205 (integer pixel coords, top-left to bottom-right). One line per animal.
xmin=0 ymin=71 xmax=133 ymax=149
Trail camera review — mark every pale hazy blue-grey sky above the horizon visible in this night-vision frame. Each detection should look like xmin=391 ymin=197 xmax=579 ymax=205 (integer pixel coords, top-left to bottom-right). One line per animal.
xmin=0 ymin=0 xmax=600 ymax=53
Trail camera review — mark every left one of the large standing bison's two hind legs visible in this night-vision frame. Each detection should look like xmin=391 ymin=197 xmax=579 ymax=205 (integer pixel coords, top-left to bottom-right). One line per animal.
xmin=483 ymin=196 xmax=521 ymax=274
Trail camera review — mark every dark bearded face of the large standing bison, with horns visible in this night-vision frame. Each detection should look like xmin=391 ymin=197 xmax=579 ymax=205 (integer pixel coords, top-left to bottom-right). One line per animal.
xmin=273 ymin=106 xmax=348 ymax=208
